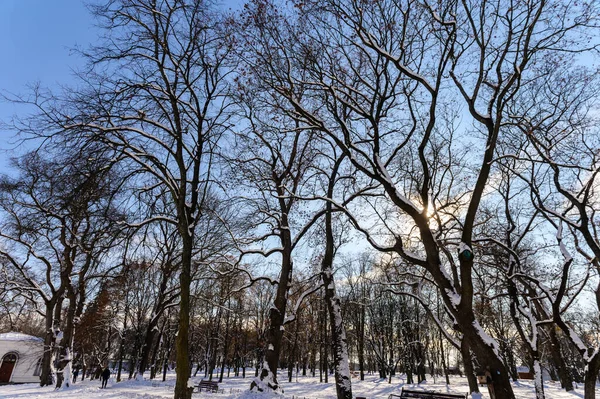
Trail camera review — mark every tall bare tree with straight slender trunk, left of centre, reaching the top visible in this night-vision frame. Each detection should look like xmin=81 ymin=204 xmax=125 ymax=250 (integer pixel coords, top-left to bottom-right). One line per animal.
xmin=6 ymin=0 xmax=237 ymax=399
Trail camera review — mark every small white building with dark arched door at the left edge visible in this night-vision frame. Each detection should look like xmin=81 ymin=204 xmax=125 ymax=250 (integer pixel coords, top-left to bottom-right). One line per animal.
xmin=0 ymin=332 xmax=44 ymax=384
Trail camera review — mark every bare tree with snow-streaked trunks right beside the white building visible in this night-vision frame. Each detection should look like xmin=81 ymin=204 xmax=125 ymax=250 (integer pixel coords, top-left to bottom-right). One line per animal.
xmin=0 ymin=151 xmax=124 ymax=387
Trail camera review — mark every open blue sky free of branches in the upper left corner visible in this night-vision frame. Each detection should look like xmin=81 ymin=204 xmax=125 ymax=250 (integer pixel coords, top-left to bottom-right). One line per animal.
xmin=0 ymin=0 xmax=242 ymax=173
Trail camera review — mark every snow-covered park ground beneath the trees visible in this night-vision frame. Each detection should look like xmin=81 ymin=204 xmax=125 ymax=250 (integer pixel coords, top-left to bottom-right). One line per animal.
xmin=0 ymin=373 xmax=600 ymax=399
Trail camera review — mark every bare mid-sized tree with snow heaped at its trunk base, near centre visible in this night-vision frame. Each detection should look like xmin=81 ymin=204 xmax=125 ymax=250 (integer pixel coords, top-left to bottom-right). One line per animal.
xmin=229 ymin=88 xmax=322 ymax=390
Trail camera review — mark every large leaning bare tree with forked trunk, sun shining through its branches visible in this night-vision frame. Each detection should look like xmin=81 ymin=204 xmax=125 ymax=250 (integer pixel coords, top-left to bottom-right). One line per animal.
xmin=239 ymin=0 xmax=594 ymax=398
